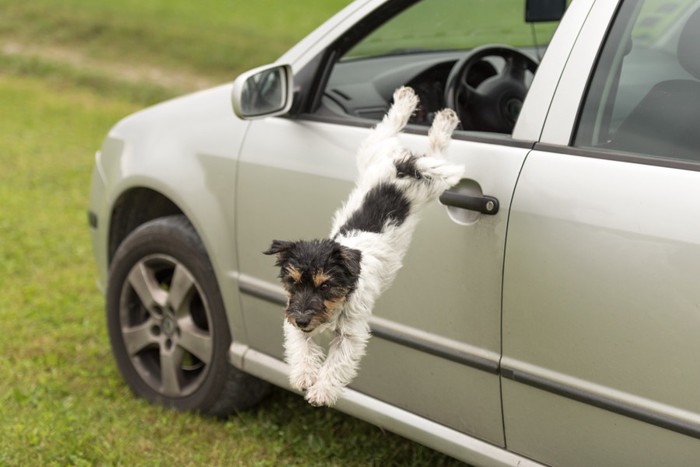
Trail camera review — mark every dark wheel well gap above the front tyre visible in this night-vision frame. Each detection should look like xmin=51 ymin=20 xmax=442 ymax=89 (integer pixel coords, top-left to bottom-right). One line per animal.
xmin=107 ymin=188 xmax=182 ymax=263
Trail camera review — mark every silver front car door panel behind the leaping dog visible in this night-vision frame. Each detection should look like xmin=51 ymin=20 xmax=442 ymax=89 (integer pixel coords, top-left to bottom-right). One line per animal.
xmin=236 ymin=1 xmax=564 ymax=446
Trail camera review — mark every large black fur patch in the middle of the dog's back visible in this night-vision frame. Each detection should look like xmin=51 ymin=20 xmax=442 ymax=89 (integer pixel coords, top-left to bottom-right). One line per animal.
xmin=338 ymin=183 xmax=411 ymax=235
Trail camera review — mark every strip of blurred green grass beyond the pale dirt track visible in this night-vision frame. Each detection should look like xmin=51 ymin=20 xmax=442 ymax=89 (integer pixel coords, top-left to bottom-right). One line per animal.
xmin=0 ymin=0 xmax=349 ymax=91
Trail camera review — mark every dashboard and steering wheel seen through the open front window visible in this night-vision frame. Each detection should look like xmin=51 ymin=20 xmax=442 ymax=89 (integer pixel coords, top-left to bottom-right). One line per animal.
xmin=323 ymin=45 xmax=538 ymax=133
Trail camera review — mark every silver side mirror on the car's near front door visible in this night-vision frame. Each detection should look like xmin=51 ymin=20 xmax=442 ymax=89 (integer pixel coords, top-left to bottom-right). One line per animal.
xmin=231 ymin=65 xmax=293 ymax=119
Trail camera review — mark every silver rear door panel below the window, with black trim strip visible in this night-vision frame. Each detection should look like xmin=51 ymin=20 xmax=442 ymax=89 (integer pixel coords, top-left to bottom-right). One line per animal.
xmin=502 ymin=149 xmax=700 ymax=465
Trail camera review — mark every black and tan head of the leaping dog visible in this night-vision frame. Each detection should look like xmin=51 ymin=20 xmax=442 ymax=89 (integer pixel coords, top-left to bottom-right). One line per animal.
xmin=263 ymin=239 xmax=362 ymax=332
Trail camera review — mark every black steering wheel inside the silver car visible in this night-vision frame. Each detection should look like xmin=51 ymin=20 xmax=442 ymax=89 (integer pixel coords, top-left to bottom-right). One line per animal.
xmin=445 ymin=45 xmax=537 ymax=133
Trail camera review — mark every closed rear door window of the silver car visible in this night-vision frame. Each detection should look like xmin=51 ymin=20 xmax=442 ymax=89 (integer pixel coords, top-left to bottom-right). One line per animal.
xmin=573 ymin=0 xmax=700 ymax=161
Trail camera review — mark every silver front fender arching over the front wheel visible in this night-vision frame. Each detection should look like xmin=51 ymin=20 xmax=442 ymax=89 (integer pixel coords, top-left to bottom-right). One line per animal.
xmin=90 ymin=84 xmax=248 ymax=348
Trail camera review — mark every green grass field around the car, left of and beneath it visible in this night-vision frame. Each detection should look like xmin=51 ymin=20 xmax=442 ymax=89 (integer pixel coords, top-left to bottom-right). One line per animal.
xmin=0 ymin=0 xmax=470 ymax=466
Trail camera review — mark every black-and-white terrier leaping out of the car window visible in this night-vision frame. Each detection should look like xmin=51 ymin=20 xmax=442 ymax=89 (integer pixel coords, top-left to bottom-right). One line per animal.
xmin=264 ymin=87 xmax=464 ymax=406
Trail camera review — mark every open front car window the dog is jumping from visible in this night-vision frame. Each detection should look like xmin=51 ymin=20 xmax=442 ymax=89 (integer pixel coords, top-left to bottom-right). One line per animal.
xmin=318 ymin=0 xmax=557 ymax=134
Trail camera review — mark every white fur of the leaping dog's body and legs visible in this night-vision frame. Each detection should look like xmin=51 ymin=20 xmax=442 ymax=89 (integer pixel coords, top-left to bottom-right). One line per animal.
xmin=284 ymin=87 xmax=464 ymax=406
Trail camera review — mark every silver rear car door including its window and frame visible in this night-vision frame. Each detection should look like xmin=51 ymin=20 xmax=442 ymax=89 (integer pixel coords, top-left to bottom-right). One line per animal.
xmin=502 ymin=0 xmax=700 ymax=465
